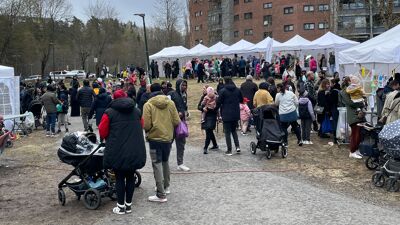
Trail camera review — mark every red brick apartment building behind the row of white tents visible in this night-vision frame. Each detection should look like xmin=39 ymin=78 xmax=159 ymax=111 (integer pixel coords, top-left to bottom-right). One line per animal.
xmin=189 ymin=0 xmax=334 ymax=47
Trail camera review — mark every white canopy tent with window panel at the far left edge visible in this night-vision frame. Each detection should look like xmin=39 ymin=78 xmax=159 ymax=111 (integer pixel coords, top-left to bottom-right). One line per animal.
xmin=0 ymin=66 xmax=20 ymax=116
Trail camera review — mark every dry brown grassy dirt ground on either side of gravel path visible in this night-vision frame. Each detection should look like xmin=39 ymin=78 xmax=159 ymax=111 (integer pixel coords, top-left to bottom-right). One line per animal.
xmin=0 ymin=80 xmax=400 ymax=224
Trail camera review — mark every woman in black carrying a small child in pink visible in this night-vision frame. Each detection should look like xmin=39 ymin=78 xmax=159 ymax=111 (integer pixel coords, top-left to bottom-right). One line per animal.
xmin=197 ymin=88 xmax=219 ymax=154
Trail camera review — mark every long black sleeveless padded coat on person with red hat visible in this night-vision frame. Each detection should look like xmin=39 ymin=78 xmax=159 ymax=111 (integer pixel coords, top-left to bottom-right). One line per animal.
xmin=103 ymin=98 xmax=146 ymax=171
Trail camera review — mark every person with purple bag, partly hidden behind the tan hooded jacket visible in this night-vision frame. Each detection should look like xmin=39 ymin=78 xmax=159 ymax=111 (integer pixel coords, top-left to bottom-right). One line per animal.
xmin=168 ymin=79 xmax=190 ymax=171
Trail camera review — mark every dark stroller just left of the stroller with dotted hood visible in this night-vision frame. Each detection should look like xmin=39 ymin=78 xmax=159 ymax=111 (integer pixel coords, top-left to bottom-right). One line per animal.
xmin=358 ymin=123 xmax=387 ymax=170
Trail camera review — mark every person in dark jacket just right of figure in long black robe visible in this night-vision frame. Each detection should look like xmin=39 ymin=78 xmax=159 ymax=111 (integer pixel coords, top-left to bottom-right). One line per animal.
xmin=76 ymin=80 xmax=96 ymax=131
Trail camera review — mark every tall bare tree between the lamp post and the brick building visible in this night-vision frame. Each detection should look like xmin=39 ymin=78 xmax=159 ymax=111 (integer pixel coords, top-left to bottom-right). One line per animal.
xmin=154 ymin=0 xmax=183 ymax=46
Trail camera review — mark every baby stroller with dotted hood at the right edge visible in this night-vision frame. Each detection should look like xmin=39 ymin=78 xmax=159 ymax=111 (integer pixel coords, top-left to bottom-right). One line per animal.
xmin=372 ymin=120 xmax=400 ymax=192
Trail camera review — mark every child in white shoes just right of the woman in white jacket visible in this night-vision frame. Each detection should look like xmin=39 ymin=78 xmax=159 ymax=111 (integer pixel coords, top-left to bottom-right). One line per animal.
xmin=299 ymin=88 xmax=315 ymax=145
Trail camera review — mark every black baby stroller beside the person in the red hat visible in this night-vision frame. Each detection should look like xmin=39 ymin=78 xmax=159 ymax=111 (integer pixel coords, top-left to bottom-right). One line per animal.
xmin=57 ymin=132 xmax=142 ymax=210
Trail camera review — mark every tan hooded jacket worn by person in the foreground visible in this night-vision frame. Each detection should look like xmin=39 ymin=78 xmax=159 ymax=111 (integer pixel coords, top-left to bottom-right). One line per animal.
xmin=143 ymin=95 xmax=181 ymax=143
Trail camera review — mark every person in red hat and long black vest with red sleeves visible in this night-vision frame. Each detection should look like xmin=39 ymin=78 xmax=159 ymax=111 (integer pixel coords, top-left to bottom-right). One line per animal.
xmin=99 ymin=90 xmax=146 ymax=214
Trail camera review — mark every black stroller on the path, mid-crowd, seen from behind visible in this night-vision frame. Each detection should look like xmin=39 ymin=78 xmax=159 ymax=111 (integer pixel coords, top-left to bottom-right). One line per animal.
xmin=250 ymin=105 xmax=288 ymax=159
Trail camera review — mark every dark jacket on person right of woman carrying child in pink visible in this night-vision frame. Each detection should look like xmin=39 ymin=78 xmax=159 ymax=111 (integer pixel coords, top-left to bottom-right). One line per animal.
xmin=217 ymin=84 xmax=243 ymax=122
